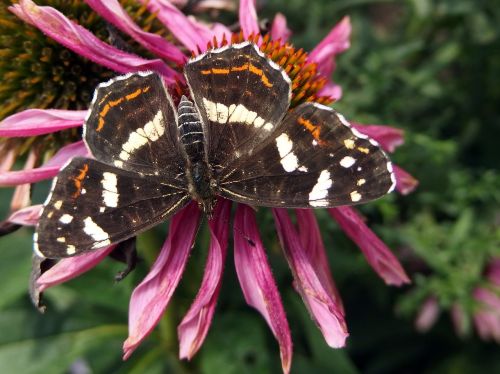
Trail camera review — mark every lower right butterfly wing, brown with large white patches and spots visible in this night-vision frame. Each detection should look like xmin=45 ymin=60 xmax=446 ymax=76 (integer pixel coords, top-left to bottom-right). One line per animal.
xmin=220 ymin=103 xmax=395 ymax=208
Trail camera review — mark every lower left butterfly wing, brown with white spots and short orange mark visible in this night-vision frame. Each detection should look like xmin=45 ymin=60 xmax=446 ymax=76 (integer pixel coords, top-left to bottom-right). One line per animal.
xmin=35 ymin=158 xmax=189 ymax=258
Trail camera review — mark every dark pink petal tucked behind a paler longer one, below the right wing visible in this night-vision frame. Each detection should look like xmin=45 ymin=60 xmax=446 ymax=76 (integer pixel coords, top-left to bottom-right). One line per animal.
xmin=295 ymin=209 xmax=345 ymax=314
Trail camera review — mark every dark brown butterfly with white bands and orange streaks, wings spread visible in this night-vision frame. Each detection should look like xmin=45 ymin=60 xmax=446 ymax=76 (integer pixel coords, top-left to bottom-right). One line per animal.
xmin=34 ymin=42 xmax=395 ymax=258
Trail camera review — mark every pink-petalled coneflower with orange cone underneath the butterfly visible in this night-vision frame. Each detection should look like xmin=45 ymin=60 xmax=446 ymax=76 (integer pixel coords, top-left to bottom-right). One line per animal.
xmin=0 ymin=0 xmax=416 ymax=372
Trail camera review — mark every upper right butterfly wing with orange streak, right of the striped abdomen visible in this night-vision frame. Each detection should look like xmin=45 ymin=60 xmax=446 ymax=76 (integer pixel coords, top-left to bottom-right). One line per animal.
xmin=185 ymin=43 xmax=291 ymax=167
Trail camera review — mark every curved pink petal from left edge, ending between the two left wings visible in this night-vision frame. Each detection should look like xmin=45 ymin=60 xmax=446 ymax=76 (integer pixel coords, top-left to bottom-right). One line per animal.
xmin=0 ymin=141 xmax=90 ymax=186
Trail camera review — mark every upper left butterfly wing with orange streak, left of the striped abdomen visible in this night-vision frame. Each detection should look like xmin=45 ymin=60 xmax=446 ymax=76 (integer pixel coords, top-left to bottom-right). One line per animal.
xmin=84 ymin=72 xmax=184 ymax=176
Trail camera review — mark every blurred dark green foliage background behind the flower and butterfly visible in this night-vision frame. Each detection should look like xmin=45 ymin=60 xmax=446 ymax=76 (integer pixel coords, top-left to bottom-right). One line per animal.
xmin=0 ymin=0 xmax=500 ymax=374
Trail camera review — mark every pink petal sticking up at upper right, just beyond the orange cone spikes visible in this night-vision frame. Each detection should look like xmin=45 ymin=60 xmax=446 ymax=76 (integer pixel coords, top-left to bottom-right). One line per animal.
xmin=309 ymin=17 xmax=352 ymax=78
